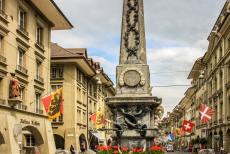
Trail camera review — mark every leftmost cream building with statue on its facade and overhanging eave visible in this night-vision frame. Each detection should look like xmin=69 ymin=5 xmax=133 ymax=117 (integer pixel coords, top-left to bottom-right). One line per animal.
xmin=0 ymin=0 xmax=73 ymax=154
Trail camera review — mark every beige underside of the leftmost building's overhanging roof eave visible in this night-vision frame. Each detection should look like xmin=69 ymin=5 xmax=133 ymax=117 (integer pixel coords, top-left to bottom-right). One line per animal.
xmin=30 ymin=0 xmax=73 ymax=30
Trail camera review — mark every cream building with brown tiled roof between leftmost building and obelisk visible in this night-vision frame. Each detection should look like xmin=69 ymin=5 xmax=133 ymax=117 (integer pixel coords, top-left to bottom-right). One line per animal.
xmin=51 ymin=43 xmax=114 ymax=152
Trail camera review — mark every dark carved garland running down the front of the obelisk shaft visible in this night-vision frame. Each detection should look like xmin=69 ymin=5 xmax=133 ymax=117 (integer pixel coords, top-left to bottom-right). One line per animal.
xmin=123 ymin=0 xmax=140 ymax=60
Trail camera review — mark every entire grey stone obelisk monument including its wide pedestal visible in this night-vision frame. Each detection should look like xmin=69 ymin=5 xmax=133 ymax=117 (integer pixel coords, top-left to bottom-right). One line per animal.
xmin=106 ymin=0 xmax=161 ymax=148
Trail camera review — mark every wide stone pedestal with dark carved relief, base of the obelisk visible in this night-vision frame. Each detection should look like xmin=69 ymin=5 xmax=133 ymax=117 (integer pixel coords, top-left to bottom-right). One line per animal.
xmin=106 ymin=95 xmax=161 ymax=149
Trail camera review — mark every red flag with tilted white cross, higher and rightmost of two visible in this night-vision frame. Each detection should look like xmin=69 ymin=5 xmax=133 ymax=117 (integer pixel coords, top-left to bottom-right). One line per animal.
xmin=199 ymin=104 xmax=214 ymax=123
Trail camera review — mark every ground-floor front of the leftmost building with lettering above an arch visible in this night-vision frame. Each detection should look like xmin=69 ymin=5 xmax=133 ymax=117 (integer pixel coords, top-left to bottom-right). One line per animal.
xmin=0 ymin=109 xmax=56 ymax=154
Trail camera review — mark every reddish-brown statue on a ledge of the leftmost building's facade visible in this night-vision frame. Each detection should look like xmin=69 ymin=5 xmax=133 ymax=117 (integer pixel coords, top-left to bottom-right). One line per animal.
xmin=9 ymin=73 xmax=21 ymax=98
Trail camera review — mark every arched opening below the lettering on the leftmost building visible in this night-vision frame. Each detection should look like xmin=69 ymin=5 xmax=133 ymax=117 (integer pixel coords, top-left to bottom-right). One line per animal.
xmin=22 ymin=126 xmax=44 ymax=154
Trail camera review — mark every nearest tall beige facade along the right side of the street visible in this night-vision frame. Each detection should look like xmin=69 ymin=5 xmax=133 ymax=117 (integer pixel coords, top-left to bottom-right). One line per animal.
xmin=170 ymin=1 xmax=230 ymax=152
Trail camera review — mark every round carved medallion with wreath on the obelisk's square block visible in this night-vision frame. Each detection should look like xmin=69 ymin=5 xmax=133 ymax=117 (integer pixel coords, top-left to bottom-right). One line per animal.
xmin=119 ymin=68 xmax=145 ymax=87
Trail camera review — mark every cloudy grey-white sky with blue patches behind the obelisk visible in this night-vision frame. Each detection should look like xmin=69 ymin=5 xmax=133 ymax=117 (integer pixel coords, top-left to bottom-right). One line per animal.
xmin=52 ymin=0 xmax=225 ymax=113
